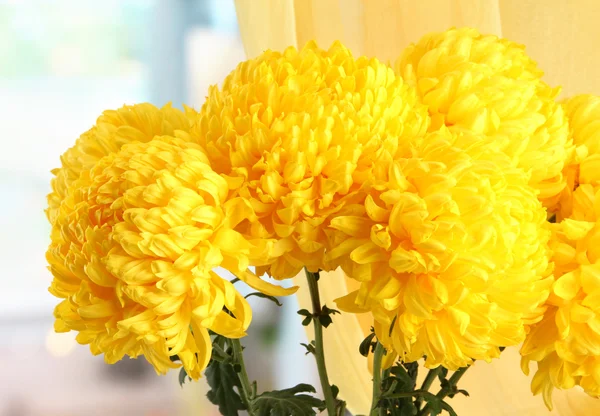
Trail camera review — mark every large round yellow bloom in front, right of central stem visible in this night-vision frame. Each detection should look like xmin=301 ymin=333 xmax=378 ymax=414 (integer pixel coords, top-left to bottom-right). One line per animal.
xmin=328 ymin=128 xmax=551 ymax=369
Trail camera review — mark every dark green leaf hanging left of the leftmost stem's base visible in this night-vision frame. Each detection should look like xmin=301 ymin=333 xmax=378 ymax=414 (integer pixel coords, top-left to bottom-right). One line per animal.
xmin=204 ymin=360 xmax=246 ymax=416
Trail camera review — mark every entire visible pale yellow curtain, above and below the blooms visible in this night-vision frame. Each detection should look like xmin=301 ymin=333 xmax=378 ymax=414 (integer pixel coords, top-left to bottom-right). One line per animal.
xmin=236 ymin=0 xmax=600 ymax=416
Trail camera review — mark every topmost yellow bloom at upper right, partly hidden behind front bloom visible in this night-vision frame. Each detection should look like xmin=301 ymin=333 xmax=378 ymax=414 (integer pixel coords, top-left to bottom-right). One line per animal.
xmin=397 ymin=28 xmax=572 ymax=206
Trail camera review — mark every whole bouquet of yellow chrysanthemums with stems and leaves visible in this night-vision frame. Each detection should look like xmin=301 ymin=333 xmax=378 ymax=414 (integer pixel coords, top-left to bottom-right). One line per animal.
xmin=47 ymin=28 xmax=600 ymax=416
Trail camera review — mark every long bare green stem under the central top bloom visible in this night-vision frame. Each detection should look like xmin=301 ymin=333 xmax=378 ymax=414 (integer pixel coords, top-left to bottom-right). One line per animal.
xmin=305 ymin=269 xmax=336 ymax=416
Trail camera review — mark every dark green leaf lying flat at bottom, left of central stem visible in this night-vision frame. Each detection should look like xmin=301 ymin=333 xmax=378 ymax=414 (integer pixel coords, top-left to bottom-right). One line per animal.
xmin=252 ymin=384 xmax=325 ymax=416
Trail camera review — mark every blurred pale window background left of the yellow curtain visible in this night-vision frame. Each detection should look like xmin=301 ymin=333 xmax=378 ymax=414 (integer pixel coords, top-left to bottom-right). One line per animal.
xmin=0 ymin=0 xmax=318 ymax=416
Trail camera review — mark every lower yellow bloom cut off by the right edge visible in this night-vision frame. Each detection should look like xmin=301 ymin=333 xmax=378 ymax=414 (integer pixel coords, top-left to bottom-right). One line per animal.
xmin=521 ymin=211 xmax=600 ymax=409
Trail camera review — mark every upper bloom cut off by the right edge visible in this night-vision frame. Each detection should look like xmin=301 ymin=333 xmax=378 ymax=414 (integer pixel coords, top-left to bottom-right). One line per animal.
xmin=556 ymin=95 xmax=600 ymax=221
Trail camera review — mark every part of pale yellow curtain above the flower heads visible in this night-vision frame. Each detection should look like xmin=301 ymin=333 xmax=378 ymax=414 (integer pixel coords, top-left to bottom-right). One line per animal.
xmin=236 ymin=0 xmax=600 ymax=96
